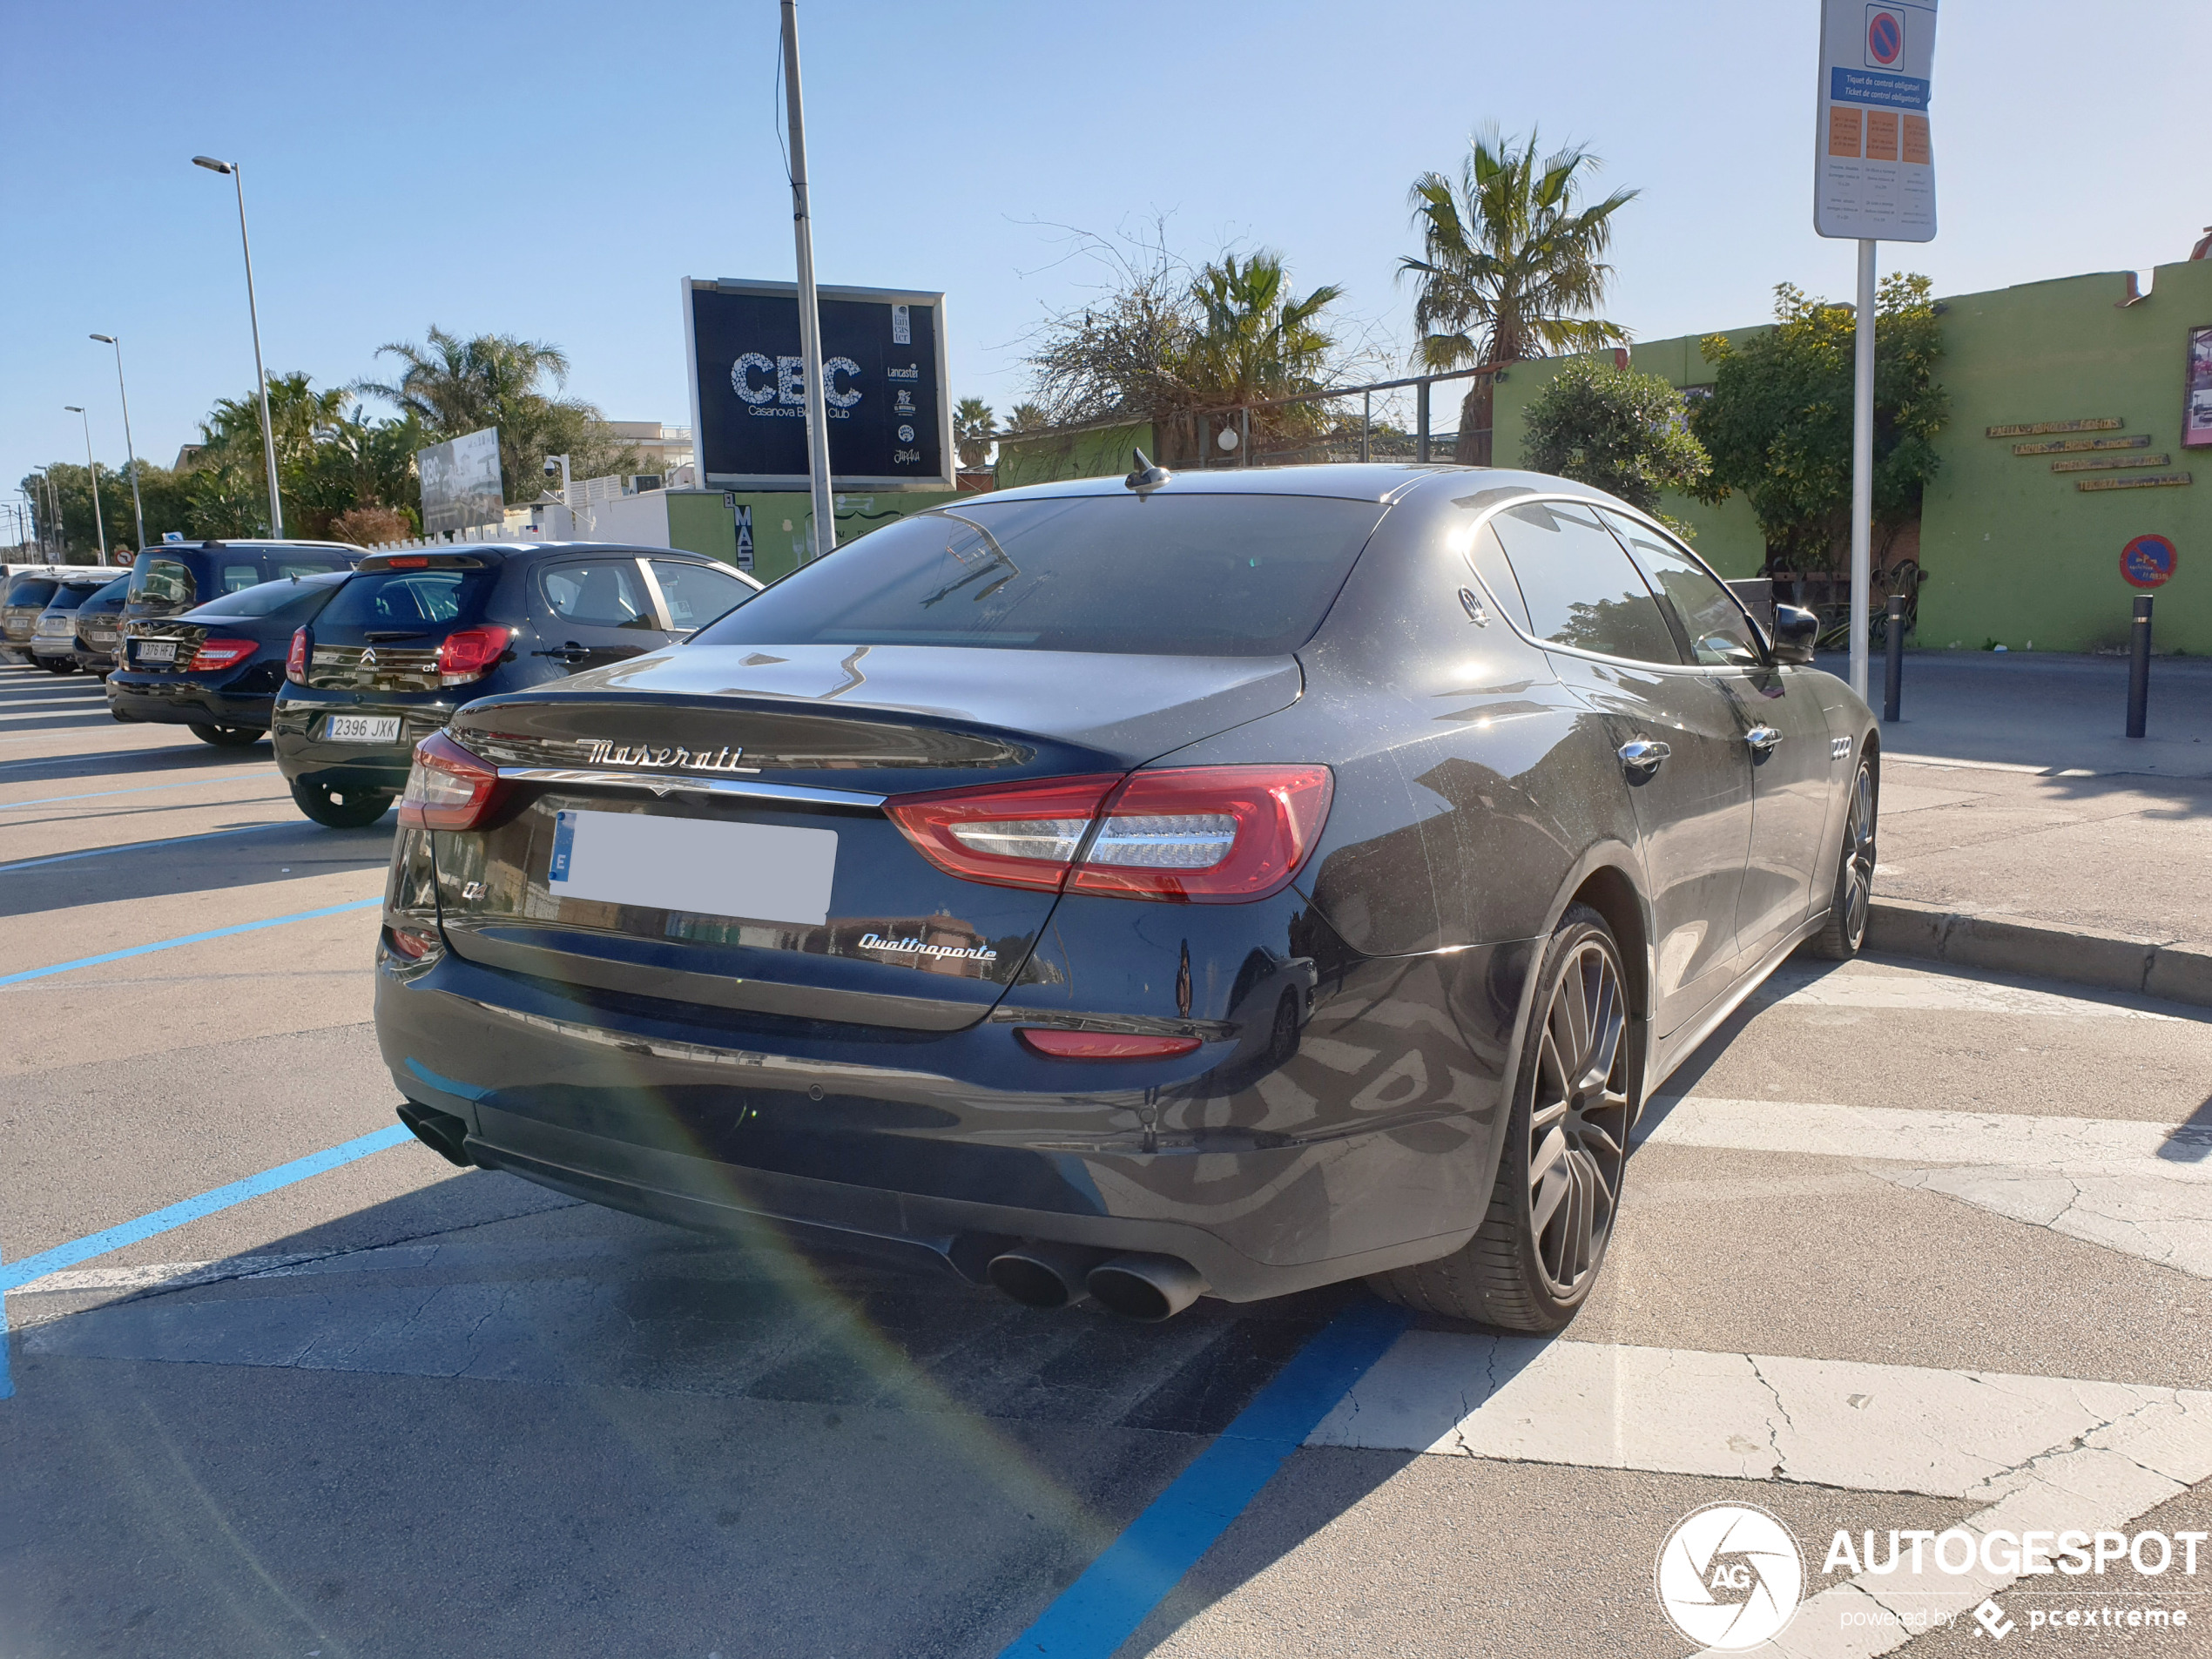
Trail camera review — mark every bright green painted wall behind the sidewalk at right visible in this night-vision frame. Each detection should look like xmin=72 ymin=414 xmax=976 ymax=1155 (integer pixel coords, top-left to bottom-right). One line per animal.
xmin=1495 ymin=261 xmax=2212 ymax=655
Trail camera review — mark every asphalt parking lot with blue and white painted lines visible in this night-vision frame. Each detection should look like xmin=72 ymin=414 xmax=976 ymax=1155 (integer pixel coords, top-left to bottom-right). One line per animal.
xmin=0 ymin=671 xmax=2212 ymax=1659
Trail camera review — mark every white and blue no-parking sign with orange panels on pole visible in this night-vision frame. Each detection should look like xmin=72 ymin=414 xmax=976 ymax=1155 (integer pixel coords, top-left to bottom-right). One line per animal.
xmin=1811 ymin=0 xmax=1936 ymax=241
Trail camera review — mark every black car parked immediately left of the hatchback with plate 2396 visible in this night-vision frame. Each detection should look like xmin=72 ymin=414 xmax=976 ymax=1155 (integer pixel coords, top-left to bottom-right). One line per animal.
xmin=108 ymin=570 xmax=347 ymax=748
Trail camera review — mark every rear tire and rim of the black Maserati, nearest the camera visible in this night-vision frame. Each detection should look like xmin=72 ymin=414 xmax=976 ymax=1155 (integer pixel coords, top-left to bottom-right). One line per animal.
xmin=1367 ymin=905 xmax=1637 ymax=1332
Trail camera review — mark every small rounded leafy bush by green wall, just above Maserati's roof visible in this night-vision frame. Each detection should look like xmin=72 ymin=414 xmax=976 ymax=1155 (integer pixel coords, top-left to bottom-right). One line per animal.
xmin=1524 ymin=358 xmax=1712 ymax=513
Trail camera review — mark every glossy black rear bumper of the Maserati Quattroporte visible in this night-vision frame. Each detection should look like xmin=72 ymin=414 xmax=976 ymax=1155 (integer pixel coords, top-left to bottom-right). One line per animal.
xmin=376 ymin=947 xmax=1527 ymax=1301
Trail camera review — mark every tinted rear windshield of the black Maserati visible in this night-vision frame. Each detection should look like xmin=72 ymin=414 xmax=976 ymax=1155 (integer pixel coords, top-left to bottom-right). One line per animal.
xmin=692 ymin=493 xmax=1385 ymax=657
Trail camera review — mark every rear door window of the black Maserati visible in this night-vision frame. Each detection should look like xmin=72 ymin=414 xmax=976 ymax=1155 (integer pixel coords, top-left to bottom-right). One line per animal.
xmin=1491 ymin=502 xmax=1681 ymax=664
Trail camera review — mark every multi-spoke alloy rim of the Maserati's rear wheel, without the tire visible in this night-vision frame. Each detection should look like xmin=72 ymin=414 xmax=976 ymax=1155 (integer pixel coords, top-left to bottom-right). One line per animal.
xmin=1527 ymin=938 xmax=1628 ymax=1298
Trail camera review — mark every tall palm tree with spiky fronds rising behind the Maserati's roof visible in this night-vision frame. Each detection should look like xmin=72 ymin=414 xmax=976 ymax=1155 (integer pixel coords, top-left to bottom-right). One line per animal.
xmin=1398 ymin=126 xmax=1639 ymax=467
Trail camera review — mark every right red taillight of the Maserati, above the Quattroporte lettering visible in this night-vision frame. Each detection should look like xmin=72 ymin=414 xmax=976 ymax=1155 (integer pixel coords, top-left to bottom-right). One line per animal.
xmin=885 ymin=765 xmax=1334 ymax=905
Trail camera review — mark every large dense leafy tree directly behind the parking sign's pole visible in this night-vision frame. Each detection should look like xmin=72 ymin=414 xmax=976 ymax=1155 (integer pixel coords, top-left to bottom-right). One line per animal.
xmin=1690 ymin=272 xmax=1949 ymax=570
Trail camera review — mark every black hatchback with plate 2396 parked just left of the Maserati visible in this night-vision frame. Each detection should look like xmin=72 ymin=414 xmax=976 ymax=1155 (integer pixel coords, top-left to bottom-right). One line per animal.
xmin=272 ymin=542 xmax=761 ymax=830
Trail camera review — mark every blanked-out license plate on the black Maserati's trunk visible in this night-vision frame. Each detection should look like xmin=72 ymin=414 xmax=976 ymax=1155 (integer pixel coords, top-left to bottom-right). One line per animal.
xmin=546 ymin=812 xmax=836 ymax=927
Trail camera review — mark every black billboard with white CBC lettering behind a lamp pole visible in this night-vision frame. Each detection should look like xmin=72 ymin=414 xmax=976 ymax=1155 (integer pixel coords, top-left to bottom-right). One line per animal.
xmin=684 ymin=277 xmax=955 ymax=491
